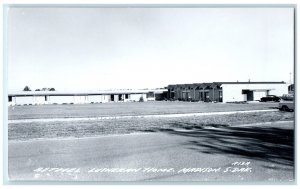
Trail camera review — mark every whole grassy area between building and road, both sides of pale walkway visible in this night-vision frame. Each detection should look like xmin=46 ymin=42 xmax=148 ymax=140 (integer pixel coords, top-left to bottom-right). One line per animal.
xmin=8 ymin=102 xmax=294 ymax=140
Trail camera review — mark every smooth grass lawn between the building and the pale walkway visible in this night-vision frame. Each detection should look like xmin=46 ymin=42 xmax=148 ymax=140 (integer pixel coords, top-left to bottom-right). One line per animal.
xmin=8 ymin=101 xmax=278 ymax=120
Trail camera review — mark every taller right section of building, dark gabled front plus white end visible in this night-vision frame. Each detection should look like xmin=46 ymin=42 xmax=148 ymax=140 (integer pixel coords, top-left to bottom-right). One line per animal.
xmin=167 ymin=81 xmax=288 ymax=102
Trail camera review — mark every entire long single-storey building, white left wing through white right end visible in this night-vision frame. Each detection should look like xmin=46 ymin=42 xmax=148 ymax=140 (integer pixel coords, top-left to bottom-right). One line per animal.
xmin=8 ymin=81 xmax=291 ymax=105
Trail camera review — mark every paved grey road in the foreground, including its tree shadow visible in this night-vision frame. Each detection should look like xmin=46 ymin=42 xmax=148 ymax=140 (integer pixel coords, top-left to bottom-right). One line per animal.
xmin=8 ymin=122 xmax=294 ymax=181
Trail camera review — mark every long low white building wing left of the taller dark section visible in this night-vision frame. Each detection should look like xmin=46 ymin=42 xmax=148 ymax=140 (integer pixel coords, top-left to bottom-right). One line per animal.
xmin=8 ymin=89 xmax=167 ymax=105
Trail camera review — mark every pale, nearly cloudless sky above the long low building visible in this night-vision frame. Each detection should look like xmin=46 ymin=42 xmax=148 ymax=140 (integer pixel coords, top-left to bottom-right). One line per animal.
xmin=6 ymin=6 xmax=294 ymax=91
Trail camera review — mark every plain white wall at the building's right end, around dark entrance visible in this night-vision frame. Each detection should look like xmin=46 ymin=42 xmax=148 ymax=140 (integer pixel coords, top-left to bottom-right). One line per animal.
xmin=222 ymin=84 xmax=288 ymax=102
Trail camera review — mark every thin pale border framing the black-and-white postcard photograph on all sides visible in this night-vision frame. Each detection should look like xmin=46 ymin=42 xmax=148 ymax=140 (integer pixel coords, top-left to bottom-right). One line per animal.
xmin=0 ymin=0 xmax=299 ymax=189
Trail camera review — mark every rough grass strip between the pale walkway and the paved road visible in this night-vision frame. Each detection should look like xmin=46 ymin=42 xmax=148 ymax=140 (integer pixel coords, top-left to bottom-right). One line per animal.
xmin=8 ymin=111 xmax=294 ymax=140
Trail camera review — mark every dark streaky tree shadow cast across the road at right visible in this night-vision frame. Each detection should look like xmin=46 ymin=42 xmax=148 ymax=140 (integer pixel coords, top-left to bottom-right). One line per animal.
xmin=140 ymin=122 xmax=294 ymax=169
